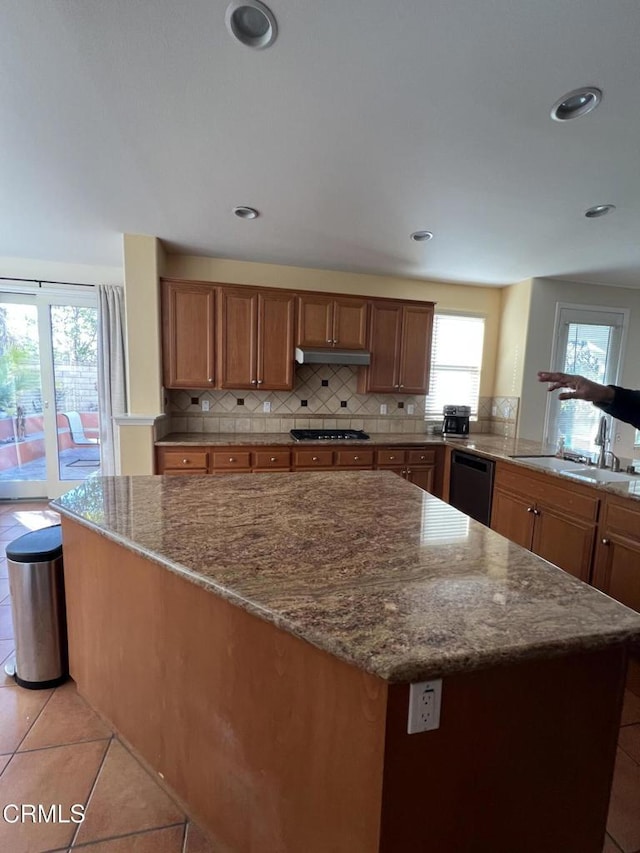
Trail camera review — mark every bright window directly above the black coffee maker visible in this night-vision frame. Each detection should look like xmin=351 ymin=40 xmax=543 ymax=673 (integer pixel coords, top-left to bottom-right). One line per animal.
xmin=425 ymin=314 xmax=484 ymax=418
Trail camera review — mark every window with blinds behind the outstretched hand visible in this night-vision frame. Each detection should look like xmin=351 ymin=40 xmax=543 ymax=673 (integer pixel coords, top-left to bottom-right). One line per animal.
xmin=545 ymin=304 xmax=626 ymax=452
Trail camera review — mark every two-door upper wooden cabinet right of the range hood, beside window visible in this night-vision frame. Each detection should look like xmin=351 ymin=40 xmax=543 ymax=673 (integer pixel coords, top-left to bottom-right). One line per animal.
xmin=359 ymin=301 xmax=433 ymax=394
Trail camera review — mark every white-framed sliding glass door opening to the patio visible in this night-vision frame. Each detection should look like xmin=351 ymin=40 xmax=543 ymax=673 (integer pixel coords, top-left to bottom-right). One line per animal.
xmin=0 ymin=288 xmax=100 ymax=498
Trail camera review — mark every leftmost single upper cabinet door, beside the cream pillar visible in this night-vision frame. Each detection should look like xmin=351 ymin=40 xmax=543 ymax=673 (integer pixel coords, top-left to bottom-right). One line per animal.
xmin=162 ymin=281 xmax=217 ymax=388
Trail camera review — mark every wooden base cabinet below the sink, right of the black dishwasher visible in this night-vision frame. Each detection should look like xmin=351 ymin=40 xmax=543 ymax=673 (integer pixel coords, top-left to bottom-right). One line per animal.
xmin=491 ymin=462 xmax=600 ymax=581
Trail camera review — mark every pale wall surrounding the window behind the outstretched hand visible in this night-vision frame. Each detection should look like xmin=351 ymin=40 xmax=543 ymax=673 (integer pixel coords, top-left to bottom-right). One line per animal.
xmin=518 ymin=278 xmax=640 ymax=457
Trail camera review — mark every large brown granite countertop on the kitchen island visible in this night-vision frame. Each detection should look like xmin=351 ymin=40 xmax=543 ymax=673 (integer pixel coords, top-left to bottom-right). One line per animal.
xmin=53 ymin=471 xmax=640 ymax=682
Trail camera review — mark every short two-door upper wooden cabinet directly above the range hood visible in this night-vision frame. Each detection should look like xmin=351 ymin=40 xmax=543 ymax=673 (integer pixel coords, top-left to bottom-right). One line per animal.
xmin=296 ymin=293 xmax=369 ymax=349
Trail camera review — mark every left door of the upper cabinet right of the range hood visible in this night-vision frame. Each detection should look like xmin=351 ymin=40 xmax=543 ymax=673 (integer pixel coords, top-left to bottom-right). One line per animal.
xmin=361 ymin=302 xmax=402 ymax=393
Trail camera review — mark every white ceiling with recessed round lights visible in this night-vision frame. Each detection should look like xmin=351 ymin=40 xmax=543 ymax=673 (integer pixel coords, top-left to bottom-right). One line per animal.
xmin=0 ymin=0 xmax=640 ymax=287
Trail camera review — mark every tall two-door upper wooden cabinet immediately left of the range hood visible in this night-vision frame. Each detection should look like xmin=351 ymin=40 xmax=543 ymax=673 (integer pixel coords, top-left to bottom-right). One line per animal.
xmin=218 ymin=287 xmax=295 ymax=391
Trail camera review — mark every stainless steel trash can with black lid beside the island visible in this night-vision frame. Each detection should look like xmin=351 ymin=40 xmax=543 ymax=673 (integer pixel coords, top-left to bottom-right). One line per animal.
xmin=6 ymin=524 xmax=68 ymax=690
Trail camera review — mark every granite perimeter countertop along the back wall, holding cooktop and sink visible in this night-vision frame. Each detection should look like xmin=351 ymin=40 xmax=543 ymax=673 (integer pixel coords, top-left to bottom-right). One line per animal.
xmin=156 ymin=432 xmax=640 ymax=500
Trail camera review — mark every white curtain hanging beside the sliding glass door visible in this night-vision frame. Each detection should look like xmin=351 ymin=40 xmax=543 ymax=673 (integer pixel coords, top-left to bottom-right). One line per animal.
xmin=96 ymin=284 xmax=127 ymax=476
